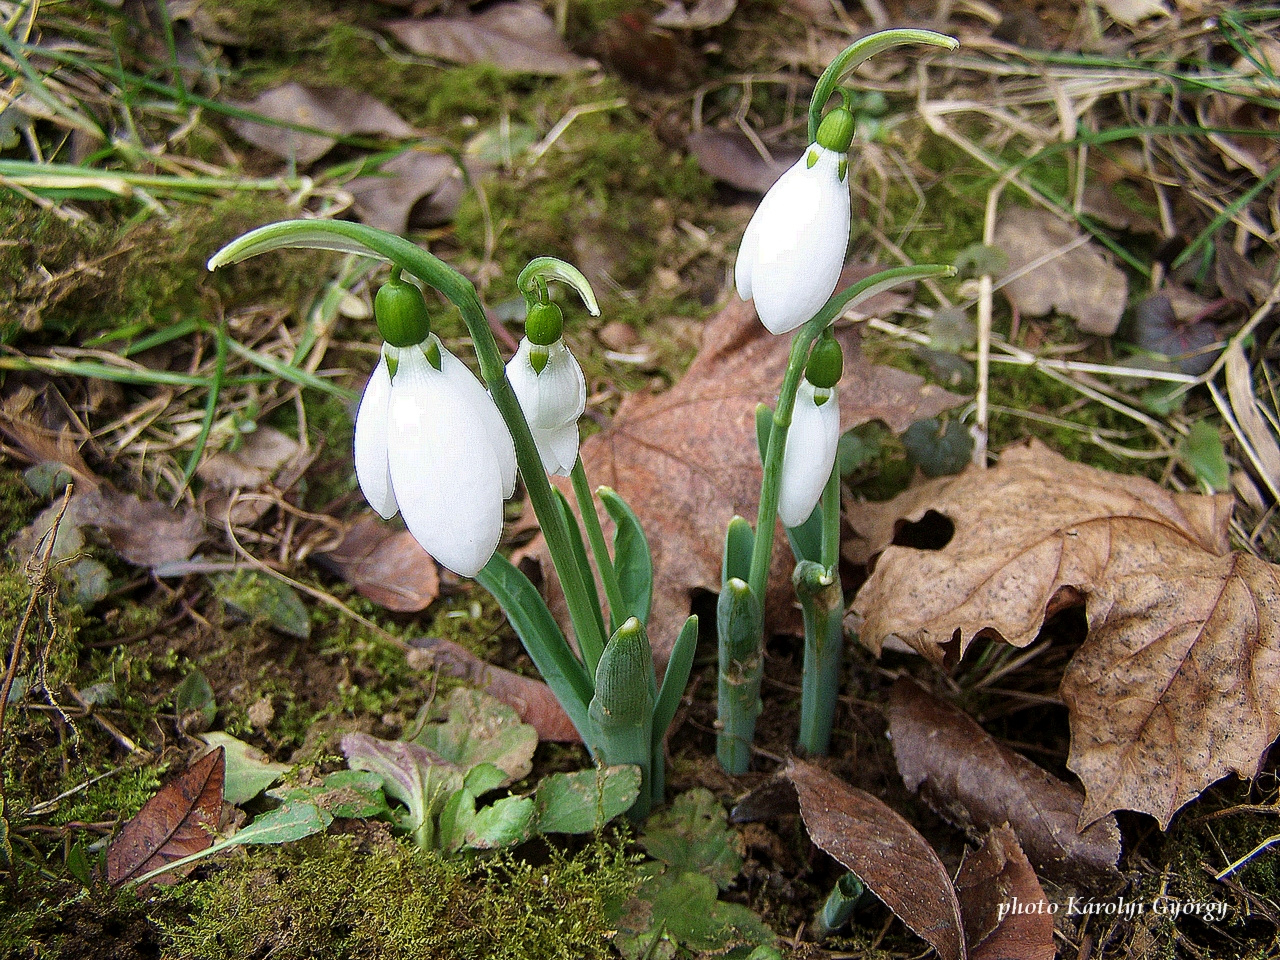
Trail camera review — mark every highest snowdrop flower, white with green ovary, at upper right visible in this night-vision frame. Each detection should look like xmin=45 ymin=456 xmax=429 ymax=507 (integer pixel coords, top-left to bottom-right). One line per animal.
xmin=733 ymin=106 xmax=854 ymax=334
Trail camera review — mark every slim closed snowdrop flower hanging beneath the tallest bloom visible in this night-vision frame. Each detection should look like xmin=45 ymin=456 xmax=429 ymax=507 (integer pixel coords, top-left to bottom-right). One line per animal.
xmin=778 ymin=330 xmax=845 ymax=526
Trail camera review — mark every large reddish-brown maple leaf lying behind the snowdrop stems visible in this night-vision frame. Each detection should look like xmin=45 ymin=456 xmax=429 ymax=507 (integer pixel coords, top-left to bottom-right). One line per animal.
xmin=529 ymin=281 xmax=961 ymax=662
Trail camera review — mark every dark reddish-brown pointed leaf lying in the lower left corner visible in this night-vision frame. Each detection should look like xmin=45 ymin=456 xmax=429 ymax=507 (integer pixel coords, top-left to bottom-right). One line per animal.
xmin=106 ymin=748 xmax=227 ymax=887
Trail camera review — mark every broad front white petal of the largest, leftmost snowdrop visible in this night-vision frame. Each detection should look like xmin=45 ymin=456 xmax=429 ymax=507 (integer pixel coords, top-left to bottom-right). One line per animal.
xmin=388 ymin=349 xmax=503 ymax=577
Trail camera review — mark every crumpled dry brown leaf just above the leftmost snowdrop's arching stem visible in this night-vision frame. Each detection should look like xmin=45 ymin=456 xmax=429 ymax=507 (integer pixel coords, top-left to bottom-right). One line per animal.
xmin=347 ymin=150 xmax=462 ymax=234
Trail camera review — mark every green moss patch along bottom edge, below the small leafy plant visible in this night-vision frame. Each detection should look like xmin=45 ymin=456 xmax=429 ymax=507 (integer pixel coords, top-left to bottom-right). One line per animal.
xmin=166 ymin=837 xmax=635 ymax=960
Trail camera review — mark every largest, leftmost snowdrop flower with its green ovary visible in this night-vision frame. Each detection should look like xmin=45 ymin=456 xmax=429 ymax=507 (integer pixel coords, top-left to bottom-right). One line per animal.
xmin=356 ymin=271 xmax=516 ymax=577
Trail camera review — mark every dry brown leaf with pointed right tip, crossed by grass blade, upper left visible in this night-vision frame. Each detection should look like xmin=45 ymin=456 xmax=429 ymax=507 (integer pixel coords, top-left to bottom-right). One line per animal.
xmin=230 ymin=83 xmax=413 ymax=166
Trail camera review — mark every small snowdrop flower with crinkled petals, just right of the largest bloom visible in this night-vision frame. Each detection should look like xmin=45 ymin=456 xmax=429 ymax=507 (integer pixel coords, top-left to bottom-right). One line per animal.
xmin=507 ymin=303 xmax=586 ymax=476
